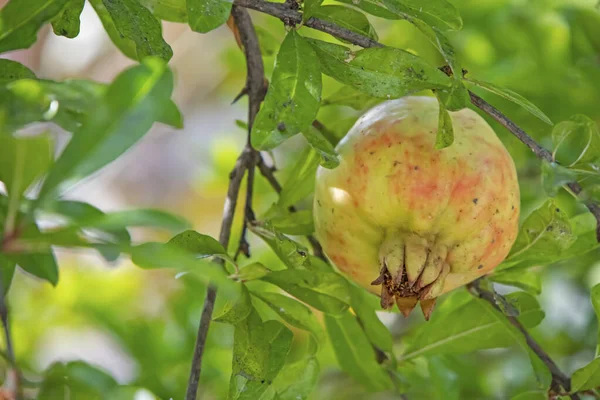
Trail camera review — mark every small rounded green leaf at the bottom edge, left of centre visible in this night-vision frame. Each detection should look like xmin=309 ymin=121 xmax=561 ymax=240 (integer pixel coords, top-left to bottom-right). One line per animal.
xmin=268 ymin=357 xmax=319 ymax=400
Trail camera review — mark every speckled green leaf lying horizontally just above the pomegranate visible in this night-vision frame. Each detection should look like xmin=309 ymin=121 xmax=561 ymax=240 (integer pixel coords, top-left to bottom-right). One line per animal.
xmin=310 ymin=39 xmax=451 ymax=99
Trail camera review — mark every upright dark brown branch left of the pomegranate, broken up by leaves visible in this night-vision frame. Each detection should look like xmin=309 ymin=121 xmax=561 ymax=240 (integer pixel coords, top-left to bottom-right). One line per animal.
xmin=185 ymin=6 xmax=265 ymax=400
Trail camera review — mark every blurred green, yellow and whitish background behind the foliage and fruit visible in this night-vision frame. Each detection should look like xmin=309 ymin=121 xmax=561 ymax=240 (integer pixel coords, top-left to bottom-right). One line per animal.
xmin=0 ymin=0 xmax=600 ymax=399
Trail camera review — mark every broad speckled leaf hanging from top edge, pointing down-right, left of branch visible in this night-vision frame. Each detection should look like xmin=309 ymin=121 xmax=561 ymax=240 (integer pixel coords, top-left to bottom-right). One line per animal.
xmin=92 ymin=0 xmax=173 ymax=61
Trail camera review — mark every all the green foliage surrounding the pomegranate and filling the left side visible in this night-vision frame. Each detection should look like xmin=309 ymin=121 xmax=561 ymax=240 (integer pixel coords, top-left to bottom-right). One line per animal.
xmin=0 ymin=0 xmax=600 ymax=400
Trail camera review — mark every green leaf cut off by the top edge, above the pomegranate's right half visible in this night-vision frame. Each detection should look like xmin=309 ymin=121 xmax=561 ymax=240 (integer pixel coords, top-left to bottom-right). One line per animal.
xmin=383 ymin=0 xmax=462 ymax=30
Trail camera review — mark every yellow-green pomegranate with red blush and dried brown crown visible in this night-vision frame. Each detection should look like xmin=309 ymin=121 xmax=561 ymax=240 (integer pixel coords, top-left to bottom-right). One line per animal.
xmin=314 ymin=97 xmax=519 ymax=319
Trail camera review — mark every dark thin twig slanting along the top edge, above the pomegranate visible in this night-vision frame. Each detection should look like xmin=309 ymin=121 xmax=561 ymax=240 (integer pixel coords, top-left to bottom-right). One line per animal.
xmin=234 ymin=0 xmax=383 ymax=47
